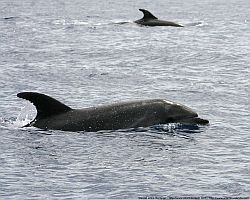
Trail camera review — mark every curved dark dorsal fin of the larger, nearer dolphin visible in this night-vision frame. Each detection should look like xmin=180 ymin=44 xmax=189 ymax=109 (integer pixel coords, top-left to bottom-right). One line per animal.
xmin=17 ymin=92 xmax=71 ymax=119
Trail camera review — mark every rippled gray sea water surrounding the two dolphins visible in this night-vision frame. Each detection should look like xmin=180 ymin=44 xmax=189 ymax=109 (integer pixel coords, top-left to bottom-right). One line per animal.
xmin=0 ymin=0 xmax=250 ymax=199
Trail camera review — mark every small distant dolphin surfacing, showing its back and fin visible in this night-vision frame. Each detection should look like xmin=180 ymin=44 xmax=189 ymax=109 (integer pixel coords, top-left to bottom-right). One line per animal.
xmin=134 ymin=9 xmax=183 ymax=27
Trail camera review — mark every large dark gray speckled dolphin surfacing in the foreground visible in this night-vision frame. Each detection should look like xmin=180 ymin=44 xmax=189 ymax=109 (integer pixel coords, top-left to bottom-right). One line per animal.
xmin=17 ymin=92 xmax=209 ymax=132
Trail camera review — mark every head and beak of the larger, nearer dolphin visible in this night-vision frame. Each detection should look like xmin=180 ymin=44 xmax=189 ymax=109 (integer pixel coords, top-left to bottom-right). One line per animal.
xmin=163 ymin=100 xmax=209 ymax=125
